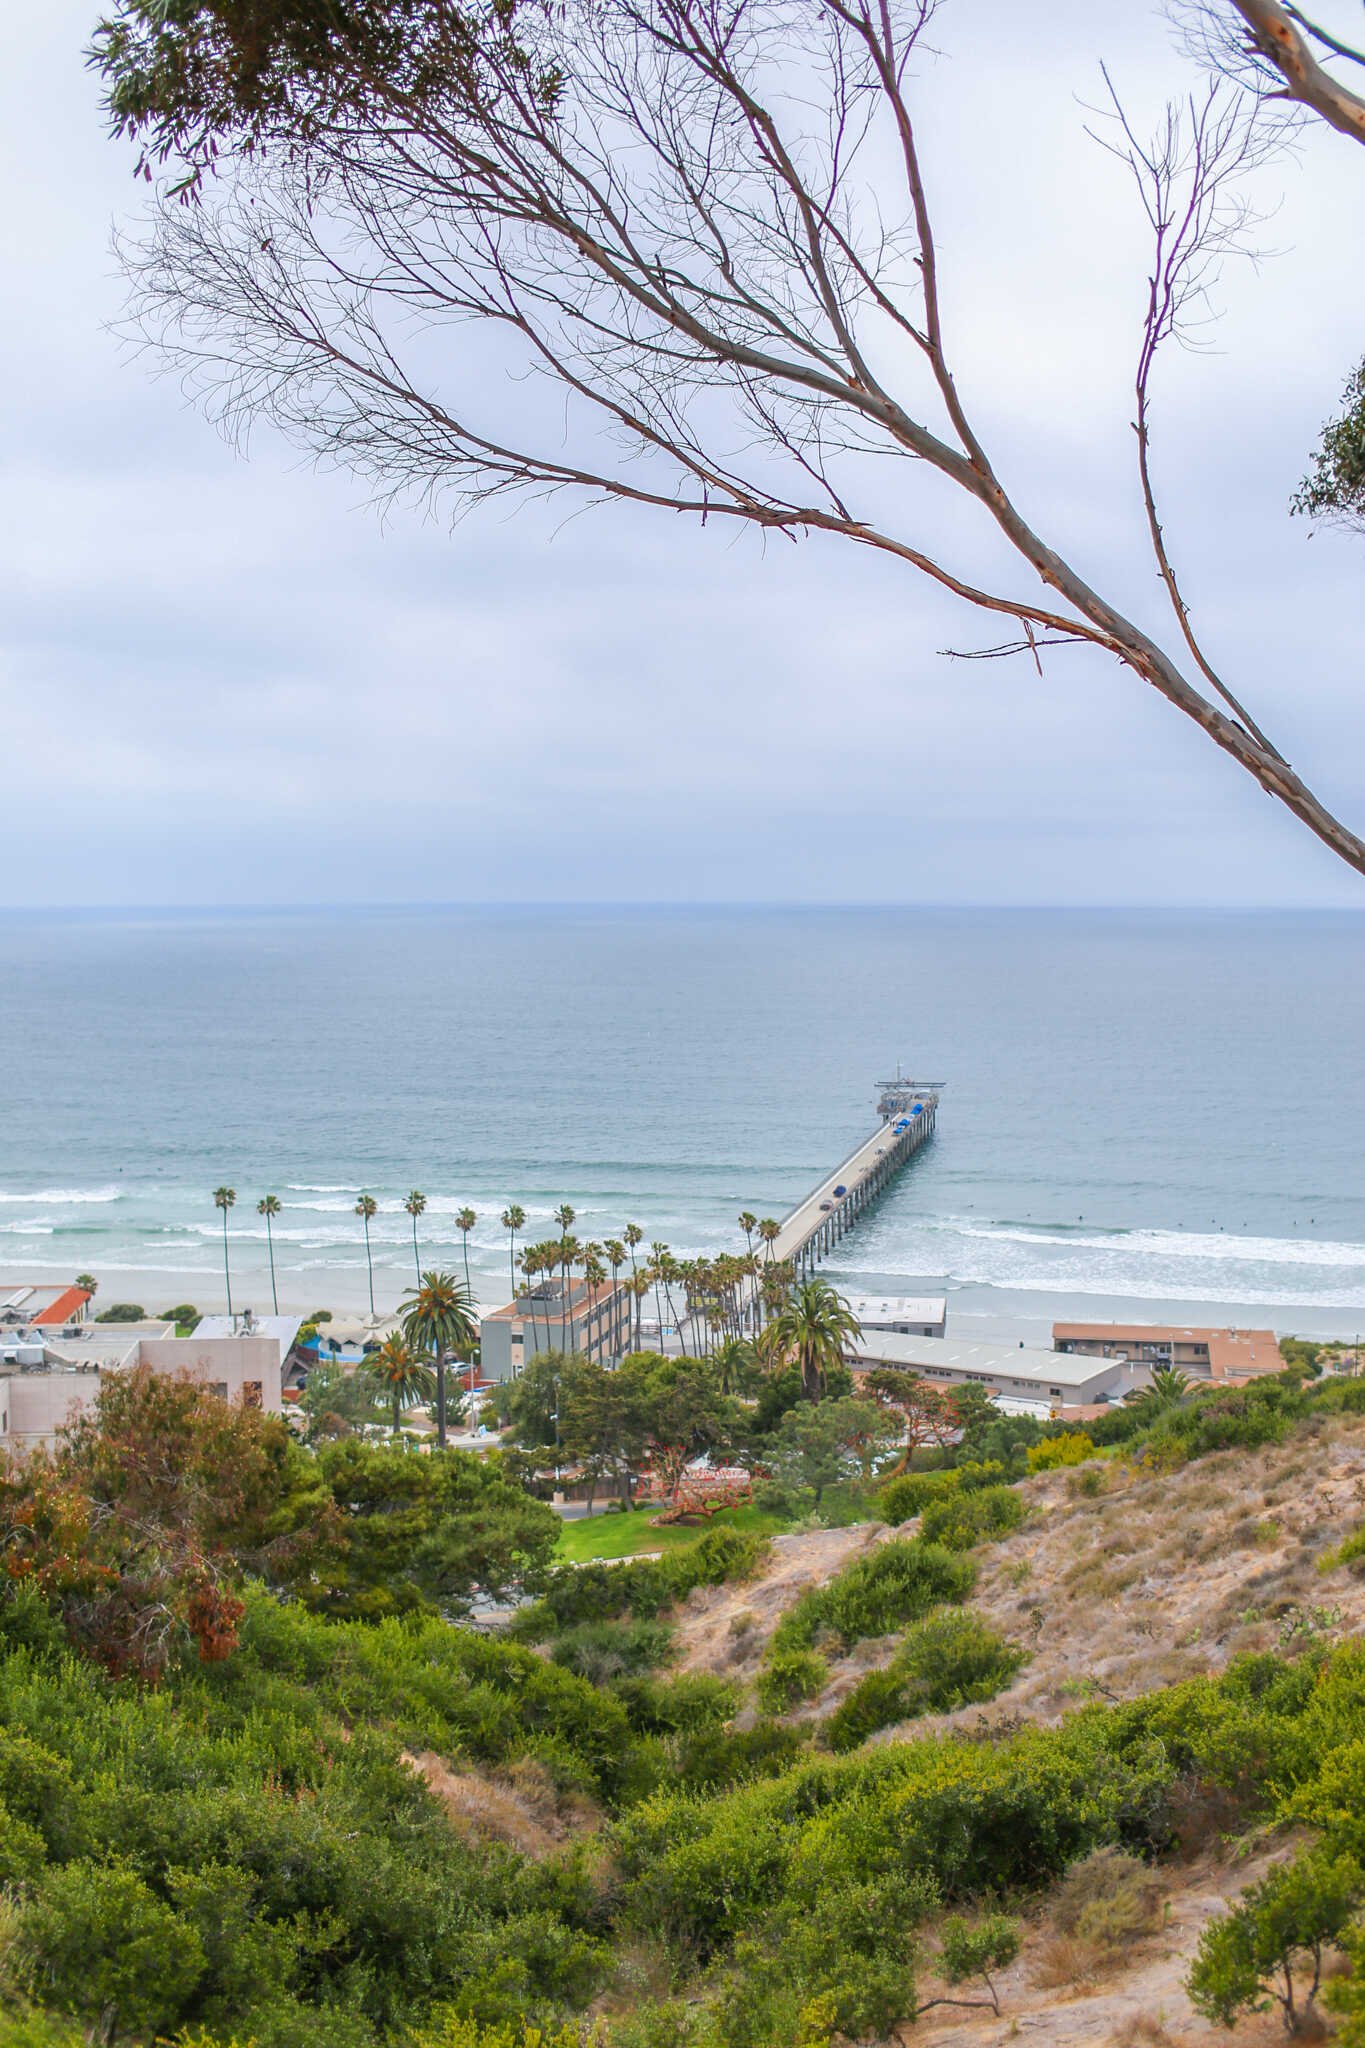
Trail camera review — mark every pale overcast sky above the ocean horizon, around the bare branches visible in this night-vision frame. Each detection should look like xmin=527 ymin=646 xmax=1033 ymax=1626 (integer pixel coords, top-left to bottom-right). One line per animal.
xmin=0 ymin=0 xmax=1365 ymax=905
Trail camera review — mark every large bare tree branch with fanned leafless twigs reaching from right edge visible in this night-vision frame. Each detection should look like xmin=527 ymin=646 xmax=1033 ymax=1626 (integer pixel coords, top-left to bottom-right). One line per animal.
xmin=114 ymin=0 xmax=1365 ymax=872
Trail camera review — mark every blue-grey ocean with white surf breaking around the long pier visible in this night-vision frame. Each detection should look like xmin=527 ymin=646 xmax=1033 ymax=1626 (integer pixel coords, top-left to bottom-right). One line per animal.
xmin=0 ymin=907 xmax=1365 ymax=1335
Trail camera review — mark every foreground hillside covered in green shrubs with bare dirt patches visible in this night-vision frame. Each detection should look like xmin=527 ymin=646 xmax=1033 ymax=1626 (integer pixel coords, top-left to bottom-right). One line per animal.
xmin=0 ymin=1351 xmax=1365 ymax=2048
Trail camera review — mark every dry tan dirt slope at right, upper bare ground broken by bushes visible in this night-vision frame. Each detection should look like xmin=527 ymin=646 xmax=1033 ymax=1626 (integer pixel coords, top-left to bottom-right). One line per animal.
xmin=679 ymin=1417 xmax=1365 ymax=1741
